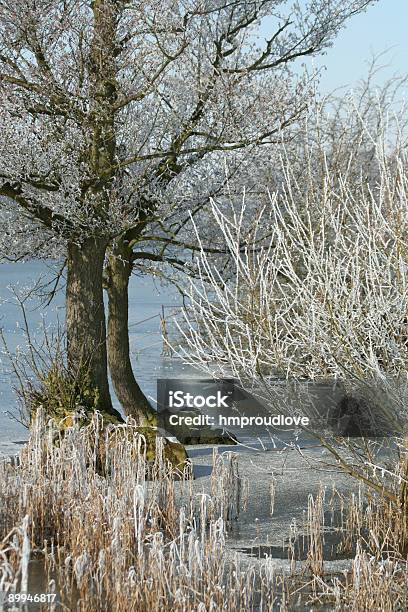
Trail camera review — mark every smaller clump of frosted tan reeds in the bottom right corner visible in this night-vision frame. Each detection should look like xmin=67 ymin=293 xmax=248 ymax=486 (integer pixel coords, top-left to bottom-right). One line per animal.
xmin=287 ymin=474 xmax=408 ymax=612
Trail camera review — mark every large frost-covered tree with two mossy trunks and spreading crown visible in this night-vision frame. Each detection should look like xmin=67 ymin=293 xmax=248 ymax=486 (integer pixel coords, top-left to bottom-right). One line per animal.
xmin=0 ymin=0 xmax=371 ymax=416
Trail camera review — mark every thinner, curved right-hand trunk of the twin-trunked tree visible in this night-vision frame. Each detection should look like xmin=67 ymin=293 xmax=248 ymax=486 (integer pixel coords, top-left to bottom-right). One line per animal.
xmin=107 ymin=243 xmax=156 ymax=426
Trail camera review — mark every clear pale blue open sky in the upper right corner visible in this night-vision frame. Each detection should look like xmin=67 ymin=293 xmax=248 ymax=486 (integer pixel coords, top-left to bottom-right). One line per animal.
xmin=263 ymin=0 xmax=408 ymax=92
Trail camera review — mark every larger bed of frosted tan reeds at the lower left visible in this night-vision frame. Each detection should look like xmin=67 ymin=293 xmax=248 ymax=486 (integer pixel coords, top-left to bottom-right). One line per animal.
xmin=0 ymin=414 xmax=274 ymax=612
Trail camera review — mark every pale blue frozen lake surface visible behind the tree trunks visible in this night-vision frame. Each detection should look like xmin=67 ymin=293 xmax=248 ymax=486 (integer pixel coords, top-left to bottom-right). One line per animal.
xmin=0 ymin=261 xmax=191 ymax=455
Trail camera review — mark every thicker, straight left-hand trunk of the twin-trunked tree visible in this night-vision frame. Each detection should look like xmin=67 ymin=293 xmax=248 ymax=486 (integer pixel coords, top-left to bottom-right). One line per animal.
xmin=66 ymin=238 xmax=120 ymax=416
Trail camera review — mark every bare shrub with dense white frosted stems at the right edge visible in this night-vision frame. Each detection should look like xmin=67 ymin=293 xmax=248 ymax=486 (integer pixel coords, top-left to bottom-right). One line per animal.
xmin=179 ymin=92 xmax=408 ymax=547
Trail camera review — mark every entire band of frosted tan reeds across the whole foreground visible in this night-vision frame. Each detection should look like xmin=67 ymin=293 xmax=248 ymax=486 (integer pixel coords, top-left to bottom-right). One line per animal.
xmin=0 ymin=411 xmax=408 ymax=612
